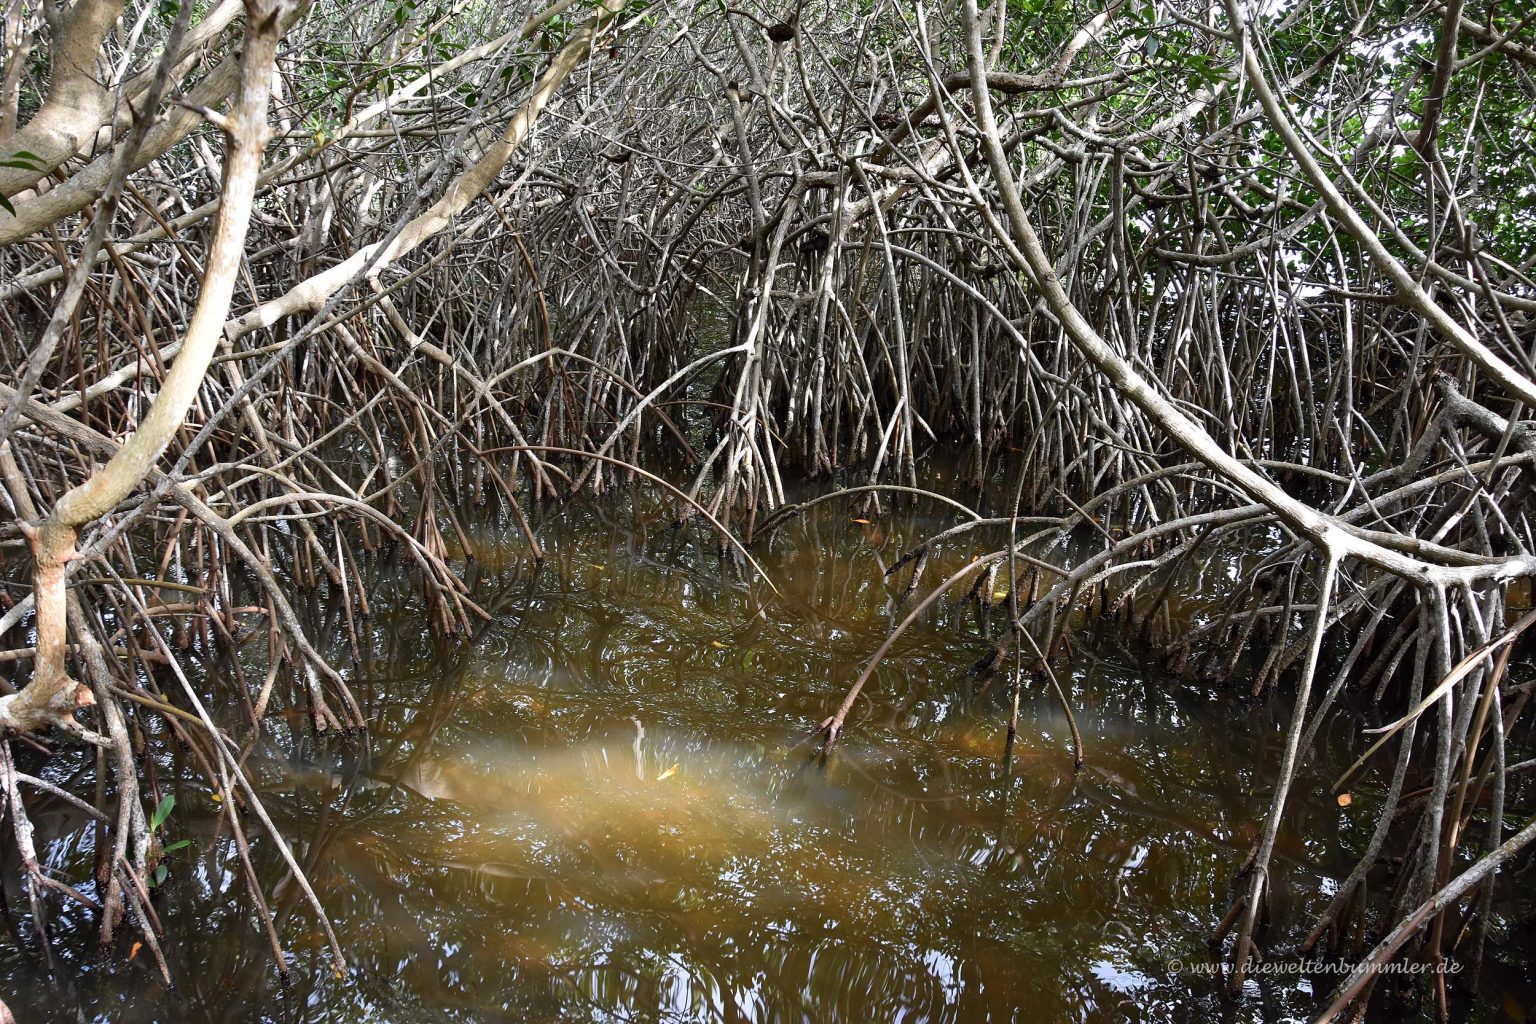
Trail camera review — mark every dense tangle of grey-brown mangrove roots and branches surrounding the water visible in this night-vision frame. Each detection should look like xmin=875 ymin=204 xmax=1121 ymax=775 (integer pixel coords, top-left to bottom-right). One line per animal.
xmin=0 ymin=0 xmax=1536 ymax=1015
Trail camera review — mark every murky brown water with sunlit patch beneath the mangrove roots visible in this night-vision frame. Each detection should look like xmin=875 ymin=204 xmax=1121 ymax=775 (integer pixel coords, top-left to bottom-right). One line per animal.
xmin=0 ymin=482 xmax=1530 ymax=1022
